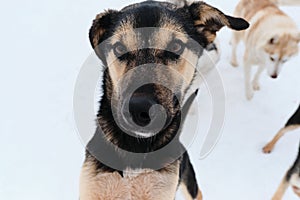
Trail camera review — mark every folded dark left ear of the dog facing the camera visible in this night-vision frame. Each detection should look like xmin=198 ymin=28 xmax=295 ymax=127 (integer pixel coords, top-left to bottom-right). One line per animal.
xmin=89 ymin=10 xmax=119 ymax=49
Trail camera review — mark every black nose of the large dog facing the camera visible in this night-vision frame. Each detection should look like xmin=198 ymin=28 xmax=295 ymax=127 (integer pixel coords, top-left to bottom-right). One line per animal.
xmin=129 ymin=94 xmax=158 ymax=127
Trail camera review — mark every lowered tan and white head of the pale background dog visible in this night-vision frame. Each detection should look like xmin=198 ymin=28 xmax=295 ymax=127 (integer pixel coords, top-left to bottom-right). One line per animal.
xmin=264 ymin=34 xmax=300 ymax=78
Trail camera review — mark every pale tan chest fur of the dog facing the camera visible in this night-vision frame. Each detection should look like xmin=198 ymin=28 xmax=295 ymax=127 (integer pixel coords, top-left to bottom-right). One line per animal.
xmin=80 ymin=162 xmax=179 ymax=200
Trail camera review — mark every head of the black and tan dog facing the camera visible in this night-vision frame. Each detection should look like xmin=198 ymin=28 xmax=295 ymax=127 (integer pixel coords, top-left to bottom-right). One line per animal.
xmin=89 ymin=1 xmax=249 ymax=137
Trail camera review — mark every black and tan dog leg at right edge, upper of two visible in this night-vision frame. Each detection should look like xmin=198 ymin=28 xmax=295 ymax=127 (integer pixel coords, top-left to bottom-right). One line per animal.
xmin=263 ymin=105 xmax=300 ymax=153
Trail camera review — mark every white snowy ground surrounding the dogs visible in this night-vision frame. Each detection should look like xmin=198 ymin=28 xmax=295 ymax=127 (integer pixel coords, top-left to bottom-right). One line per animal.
xmin=0 ymin=0 xmax=300 ymax=200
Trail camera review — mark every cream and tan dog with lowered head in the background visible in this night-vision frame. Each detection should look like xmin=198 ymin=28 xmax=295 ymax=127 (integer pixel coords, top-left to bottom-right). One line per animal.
xmin=231 ymin=0 xmax=299 ymax=100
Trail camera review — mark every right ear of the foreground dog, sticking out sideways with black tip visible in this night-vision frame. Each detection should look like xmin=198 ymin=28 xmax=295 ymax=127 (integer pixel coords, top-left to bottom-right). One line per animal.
xmin=188 ymin=1 xmax=249 ymax=43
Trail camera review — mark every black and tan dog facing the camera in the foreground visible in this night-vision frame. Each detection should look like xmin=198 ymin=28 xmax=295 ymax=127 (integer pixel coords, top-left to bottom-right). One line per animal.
xmin=80 ymin=1 xmax=249 ymax=200
